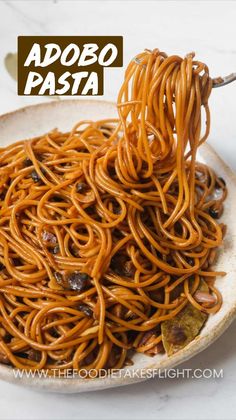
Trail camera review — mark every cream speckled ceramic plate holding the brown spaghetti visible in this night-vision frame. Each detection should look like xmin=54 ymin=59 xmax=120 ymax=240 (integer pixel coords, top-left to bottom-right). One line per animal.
xmin=0 ymin=100 xmax=236 ymax=393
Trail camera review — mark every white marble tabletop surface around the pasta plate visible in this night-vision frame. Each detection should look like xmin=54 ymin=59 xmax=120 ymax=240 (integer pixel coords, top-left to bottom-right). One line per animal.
xmin=0 ymin=0 xmax=236 ymax=420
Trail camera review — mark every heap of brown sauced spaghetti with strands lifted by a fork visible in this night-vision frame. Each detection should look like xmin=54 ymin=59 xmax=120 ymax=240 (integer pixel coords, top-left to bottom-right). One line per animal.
xmin=0 ymin=49 xmax=227 ymax=371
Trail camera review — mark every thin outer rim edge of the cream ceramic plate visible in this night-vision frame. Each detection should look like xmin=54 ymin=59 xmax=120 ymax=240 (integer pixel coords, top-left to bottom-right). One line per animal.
xmin=0 ymin=99 xmax=236 ymax=393
